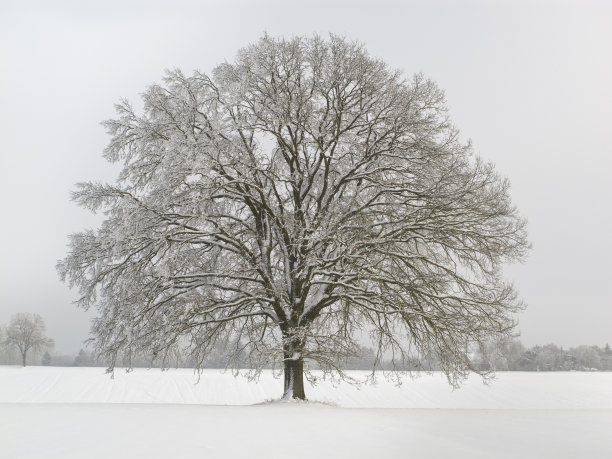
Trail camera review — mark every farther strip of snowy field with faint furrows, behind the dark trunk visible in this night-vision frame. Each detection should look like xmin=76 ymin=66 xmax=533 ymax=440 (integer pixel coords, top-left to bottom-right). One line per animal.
xmin=0 ymin=366 xmax=612 ymax=409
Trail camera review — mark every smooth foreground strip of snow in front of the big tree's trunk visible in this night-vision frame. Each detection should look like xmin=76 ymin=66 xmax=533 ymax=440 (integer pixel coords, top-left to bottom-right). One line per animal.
xmin=0 ymin=403 xmax=612 ymax=459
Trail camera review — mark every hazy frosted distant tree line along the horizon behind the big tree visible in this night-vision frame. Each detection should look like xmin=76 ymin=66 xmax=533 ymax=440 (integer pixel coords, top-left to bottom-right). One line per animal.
xmin=0 ymin=313 xmax=612 ymax=371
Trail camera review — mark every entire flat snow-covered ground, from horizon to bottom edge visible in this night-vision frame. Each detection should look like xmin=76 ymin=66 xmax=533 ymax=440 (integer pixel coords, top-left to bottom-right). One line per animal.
xmin=0 ymin=366 xmax=612 ymax=459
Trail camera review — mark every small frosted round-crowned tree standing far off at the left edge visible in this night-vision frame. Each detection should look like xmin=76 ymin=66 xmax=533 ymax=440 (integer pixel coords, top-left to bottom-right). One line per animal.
xmin=4 ymin=312 xmax=55 ymax=367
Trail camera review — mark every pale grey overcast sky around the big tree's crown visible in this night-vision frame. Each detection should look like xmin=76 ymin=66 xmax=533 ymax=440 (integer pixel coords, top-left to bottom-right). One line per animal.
xmin=0 ymin=0 xmax=612 ymax=353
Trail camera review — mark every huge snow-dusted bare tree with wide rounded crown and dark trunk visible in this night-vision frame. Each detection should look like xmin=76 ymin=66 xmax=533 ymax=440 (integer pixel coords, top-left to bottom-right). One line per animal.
xmin=58 ymin=36 xmax=528 ymax=398
